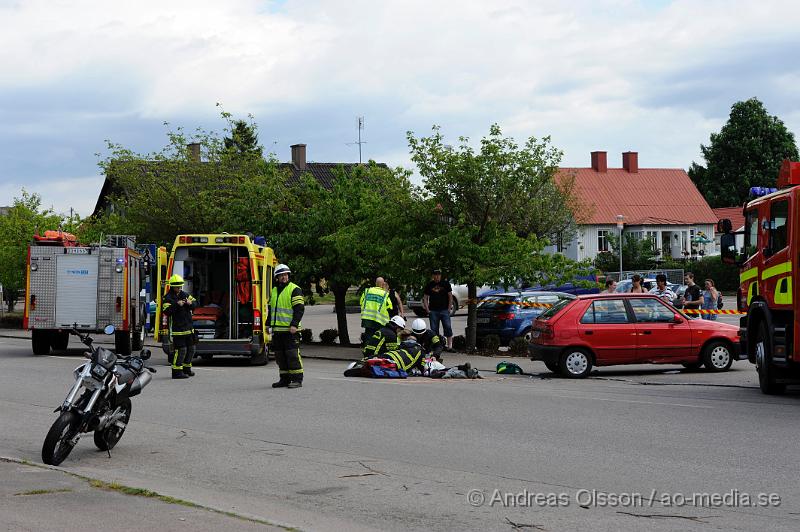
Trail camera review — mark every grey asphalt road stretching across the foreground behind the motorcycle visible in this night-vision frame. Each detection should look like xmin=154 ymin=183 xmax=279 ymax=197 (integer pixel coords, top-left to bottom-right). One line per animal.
xmin=0 ymin=332 xmax=800 ymax=531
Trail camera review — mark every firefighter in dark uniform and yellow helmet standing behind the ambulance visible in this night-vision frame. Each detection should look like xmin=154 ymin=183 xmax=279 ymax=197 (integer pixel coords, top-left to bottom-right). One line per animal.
xmin=161 ymin=274 xmax=197 ymax=379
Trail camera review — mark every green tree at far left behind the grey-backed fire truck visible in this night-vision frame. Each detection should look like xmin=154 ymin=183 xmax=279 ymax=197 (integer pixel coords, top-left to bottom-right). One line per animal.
xmin=0 ymin=189 xmax=65 ymax=312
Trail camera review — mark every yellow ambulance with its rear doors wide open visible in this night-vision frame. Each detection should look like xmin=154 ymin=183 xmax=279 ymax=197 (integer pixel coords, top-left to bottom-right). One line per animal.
xmin=155 ymin=233 xmax=277 ymax=365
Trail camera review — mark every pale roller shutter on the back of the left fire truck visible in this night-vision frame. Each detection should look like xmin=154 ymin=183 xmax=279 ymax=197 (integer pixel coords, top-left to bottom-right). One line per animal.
xmin=55 ymin=254 xmax=98 ymax=328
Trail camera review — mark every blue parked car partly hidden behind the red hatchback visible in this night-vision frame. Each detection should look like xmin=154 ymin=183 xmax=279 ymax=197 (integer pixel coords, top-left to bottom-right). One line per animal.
xmin=476 ymin=291 xmax=575 ymax=345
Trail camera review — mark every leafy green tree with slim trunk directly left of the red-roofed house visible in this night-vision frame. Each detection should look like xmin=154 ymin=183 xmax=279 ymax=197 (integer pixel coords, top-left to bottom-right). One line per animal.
xmin=408 ymin=125 xmax=582 ymax=349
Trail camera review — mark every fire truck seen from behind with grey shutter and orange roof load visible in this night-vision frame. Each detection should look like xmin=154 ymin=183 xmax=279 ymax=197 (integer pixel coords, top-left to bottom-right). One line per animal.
xmin=23 ymin=231 xmax=145 ymax=355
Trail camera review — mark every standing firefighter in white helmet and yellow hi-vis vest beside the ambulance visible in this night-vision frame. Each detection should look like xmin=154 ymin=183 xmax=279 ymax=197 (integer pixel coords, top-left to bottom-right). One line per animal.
xmin=267 ymin=264 xmax=305 ymax=388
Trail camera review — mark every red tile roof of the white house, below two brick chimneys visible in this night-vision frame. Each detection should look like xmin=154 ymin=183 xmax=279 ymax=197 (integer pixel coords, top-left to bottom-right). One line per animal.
xmin=559 ymin=168 xmax=717 ymax=225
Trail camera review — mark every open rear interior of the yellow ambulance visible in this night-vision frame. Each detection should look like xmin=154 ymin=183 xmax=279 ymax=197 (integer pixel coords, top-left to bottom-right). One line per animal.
xmin=173 ymin=246 xmax=253 ymax=340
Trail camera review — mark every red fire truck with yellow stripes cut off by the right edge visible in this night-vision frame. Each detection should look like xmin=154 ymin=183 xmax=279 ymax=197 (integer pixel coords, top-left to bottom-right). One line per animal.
xmin=718 ymin=160 xmax=800 ymax=394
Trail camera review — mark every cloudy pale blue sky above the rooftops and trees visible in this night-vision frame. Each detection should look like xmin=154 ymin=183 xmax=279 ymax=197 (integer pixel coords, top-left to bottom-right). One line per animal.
xmin=0 ymin=0 xmax=800 ymax=216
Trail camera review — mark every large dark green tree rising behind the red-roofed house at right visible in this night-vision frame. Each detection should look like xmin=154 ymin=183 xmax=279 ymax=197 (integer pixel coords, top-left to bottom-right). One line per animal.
xmin=689 ymin=98 xmax=798 ymax=207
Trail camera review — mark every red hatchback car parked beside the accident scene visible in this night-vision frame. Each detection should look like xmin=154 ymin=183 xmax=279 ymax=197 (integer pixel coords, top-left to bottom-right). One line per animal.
xmin=530 ymin=294 xmax=739 ymax=378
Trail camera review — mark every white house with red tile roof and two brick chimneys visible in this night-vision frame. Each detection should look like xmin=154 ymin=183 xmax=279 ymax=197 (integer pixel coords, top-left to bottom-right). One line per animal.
xmin=555 ymin=151 xmax=718 ymax=260
